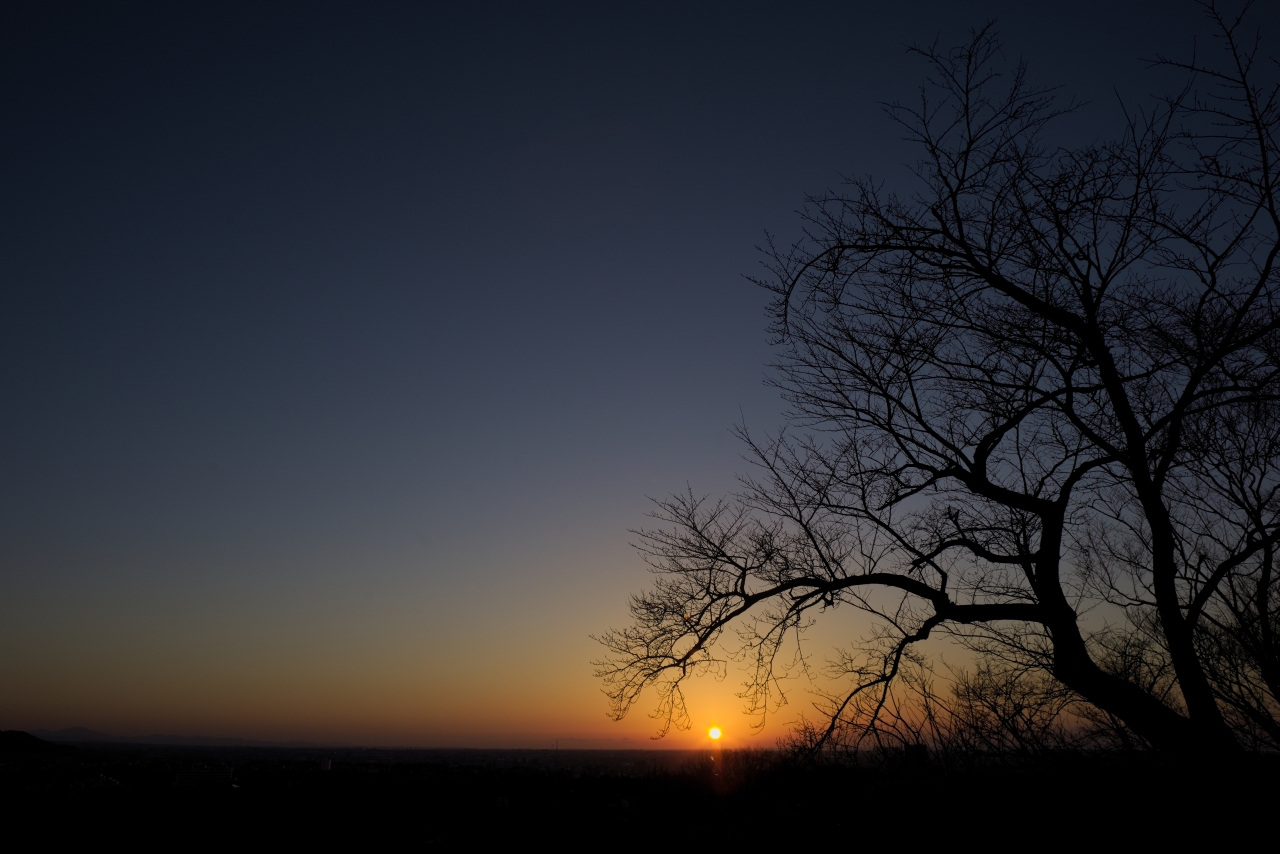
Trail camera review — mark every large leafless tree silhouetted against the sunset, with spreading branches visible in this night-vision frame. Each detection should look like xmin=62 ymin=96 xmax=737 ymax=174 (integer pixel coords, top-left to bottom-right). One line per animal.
xmin=599 ymin=5 xmax=1280 ymax=753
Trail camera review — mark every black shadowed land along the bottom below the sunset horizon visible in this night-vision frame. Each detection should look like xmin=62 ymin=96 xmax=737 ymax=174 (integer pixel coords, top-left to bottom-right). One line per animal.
xmin=0 ymin=732 xmax=1280 ymax=850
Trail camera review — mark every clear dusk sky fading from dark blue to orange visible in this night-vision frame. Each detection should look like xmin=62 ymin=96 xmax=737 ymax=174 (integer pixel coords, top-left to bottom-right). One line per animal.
xmin=0 ymin=1 xmax=1280 ymax=746
